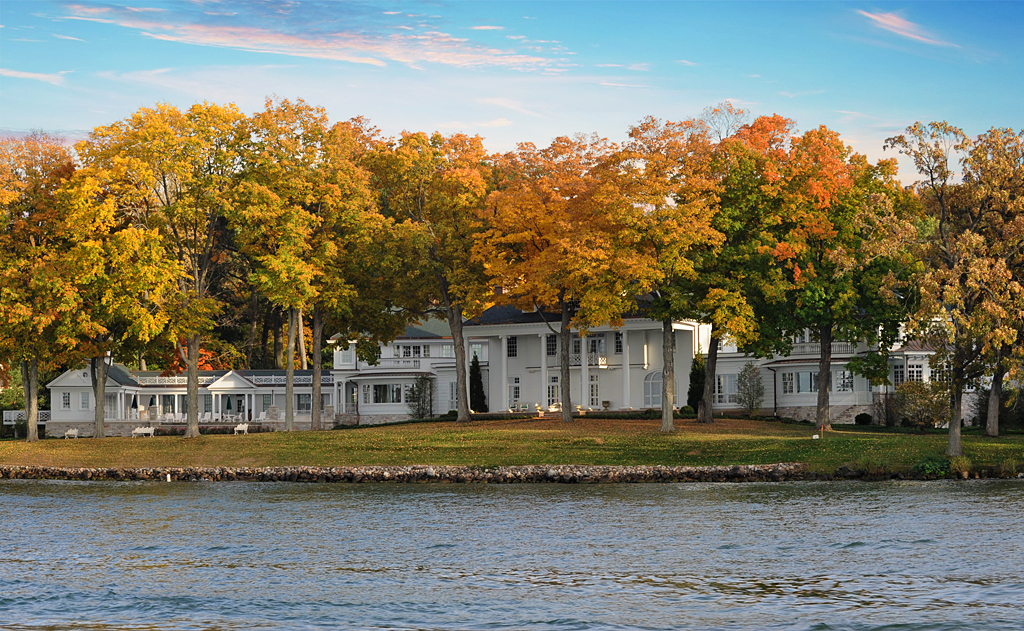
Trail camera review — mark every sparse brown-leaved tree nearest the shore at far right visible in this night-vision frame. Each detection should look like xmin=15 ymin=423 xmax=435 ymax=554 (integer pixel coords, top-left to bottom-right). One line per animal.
xmin=887 ymin=122 xmax=1024 ymax=456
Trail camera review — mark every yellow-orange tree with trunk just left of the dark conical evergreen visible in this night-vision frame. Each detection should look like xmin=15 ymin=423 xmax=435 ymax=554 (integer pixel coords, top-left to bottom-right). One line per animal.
xmin=366 ymin=132 xmax=490 ymax=421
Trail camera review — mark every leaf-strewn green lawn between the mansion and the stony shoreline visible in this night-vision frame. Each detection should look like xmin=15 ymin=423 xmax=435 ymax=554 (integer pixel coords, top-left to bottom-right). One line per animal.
xmin=0 ymin=418 xmax=1024 ymax=472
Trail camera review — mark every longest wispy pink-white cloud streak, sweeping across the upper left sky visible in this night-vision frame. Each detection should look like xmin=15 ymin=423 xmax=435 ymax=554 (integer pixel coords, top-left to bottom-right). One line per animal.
xmin=65 ymin=2 xmax=563 ymax=71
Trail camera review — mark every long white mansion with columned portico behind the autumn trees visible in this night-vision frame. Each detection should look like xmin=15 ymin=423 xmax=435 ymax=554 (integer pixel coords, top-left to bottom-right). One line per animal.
xmin=29 ymin=307 xmax=931 ymax=435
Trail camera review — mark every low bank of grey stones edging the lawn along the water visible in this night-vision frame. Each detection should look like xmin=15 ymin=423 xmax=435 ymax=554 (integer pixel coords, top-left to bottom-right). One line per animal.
xmin=0 ymin=463 xmax=817 ymax=483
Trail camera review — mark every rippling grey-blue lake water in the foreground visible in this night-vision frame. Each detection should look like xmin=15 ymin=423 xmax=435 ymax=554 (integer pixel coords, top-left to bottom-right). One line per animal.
xmin=0 ymin=480 xmax=1024 ymax=631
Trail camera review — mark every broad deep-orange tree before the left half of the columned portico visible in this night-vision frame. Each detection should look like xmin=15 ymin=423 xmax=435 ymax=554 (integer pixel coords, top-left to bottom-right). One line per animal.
xmin=476 ymin=136 xmax=653 ymax=422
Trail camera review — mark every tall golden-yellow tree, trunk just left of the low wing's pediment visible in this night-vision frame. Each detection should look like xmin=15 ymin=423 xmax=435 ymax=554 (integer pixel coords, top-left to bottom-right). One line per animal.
xmin=77 ymin=103 xmax=245 ymax=437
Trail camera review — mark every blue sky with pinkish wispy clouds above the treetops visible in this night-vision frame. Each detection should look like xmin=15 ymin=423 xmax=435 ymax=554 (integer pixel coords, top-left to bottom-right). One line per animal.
xmin=0 ymin=0 xmax=1024 ymax=178
